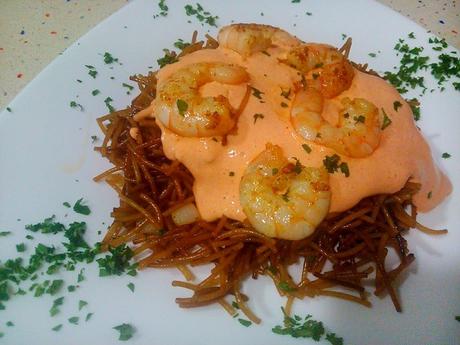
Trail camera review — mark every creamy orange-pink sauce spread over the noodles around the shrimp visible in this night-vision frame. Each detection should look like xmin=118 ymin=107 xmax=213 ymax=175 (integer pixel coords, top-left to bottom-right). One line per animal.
xmin=146 ymin=48 xmax=452 ymax=221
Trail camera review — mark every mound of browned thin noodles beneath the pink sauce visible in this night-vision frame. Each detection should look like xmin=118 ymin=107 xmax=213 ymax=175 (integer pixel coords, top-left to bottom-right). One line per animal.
xmin=94 ymin=33 xmax=445 ymax=316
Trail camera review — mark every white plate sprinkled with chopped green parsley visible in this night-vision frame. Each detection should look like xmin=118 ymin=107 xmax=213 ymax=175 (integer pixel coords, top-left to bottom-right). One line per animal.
xmin=0 ymin=0 xmax=460 ymax=345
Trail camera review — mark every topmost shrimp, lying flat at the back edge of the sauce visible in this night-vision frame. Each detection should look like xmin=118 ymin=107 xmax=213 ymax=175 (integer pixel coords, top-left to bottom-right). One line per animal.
xmin=217 ymin=24 xmax=301 ymax=57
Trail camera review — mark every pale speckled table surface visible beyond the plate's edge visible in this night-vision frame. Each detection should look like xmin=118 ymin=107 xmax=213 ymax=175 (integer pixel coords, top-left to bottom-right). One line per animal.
xmin=0 ymin=0 xmax=460 ymax=109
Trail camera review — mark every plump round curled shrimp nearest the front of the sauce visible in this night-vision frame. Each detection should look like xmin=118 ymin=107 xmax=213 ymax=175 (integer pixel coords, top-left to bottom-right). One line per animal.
xmin=240 ymin=144 xmax=331 ymax=240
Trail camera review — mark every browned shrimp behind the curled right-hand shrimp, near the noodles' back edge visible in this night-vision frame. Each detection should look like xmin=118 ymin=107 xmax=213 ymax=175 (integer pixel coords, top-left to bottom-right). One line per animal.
xmin=283 ymin=43 xmax=354 ymax=98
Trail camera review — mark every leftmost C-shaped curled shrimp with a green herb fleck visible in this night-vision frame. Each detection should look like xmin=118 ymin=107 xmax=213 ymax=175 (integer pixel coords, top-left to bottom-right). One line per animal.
xmin=153 ymin=62 xmax=249 ymax=137
